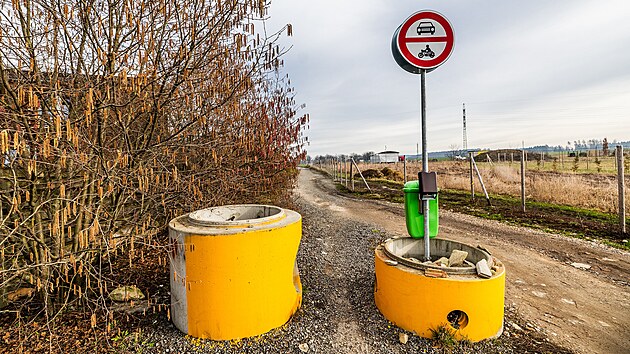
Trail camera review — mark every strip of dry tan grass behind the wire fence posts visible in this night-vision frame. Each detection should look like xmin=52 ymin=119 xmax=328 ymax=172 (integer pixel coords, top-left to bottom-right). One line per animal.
xmin=344 ymin=161 xmax=630 ymax=213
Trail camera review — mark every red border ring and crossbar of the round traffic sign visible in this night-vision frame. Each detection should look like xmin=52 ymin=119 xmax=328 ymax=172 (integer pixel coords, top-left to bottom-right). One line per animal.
xmin=396 ymin=11 xmax=455 ymax=69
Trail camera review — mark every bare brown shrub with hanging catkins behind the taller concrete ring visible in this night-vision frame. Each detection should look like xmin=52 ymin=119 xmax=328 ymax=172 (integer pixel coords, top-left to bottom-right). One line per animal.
xmin=0 ymin=0 xmax=308 ymax=322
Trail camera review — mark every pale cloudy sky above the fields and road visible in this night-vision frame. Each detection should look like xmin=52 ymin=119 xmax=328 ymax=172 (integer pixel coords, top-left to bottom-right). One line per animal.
xmin=266 ymin=0 xmax=630 ymax=157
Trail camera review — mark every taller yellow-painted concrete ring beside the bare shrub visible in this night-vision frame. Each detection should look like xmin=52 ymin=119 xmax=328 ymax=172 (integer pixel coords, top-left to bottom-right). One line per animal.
xmin=169 ymin=205 xmax=302 ymax=340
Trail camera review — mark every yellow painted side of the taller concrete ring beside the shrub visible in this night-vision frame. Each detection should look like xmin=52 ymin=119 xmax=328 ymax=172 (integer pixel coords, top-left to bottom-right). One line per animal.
xmin=185 ymin=218 xmax=302 ymax=340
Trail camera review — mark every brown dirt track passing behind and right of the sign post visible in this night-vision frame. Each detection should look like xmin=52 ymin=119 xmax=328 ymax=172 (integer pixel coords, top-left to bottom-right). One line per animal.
xmin=297 ymin=170 xmax=630 ymax=353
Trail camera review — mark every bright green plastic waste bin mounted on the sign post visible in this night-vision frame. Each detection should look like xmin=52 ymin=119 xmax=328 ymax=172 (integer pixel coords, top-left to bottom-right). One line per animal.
xmin=403 ymin=181 xmax=438 ymax=238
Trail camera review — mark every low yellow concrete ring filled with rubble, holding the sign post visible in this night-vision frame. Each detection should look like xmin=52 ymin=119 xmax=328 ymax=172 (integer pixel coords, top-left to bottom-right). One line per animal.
xmin=374 ymin=237 xmax=505 ymax=342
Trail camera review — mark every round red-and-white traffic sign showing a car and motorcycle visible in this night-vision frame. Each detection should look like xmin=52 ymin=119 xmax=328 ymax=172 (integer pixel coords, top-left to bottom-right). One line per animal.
xmin=392 ymin=10 xmax=455 ymax=74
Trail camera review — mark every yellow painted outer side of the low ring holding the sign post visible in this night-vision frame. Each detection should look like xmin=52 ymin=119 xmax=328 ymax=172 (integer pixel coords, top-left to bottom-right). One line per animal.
xmin=374 ymin=248 xmax=505 ymax=342
